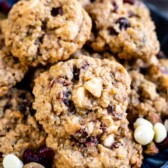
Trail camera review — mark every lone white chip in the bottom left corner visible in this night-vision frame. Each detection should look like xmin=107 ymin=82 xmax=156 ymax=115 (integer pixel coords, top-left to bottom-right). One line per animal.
xmin=3 ymin=154 xmax=23 ymax=168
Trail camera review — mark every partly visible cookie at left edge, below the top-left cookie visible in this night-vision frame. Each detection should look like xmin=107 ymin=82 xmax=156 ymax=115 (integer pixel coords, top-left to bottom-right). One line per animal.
xmin=0 ymin=50 xmax=28 ymax=97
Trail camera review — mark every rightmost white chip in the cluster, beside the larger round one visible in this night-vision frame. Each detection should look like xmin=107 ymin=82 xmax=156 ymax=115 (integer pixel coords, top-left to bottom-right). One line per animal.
xmin=153 ymin=123 xmax=167 ymax=143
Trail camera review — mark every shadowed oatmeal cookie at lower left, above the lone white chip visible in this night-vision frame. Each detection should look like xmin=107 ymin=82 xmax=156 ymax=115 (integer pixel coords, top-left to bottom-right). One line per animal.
xmin=0 ymin=89 xmax=46 ymax=158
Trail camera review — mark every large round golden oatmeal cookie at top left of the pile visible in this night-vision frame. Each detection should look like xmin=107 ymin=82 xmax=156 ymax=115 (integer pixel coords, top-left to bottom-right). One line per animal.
xmin=3 ymin=0 xmax=91 ymax=66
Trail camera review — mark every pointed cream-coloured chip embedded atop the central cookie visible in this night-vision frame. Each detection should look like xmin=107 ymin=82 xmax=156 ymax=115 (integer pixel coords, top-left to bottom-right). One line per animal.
xmin=84 ymin=78 xmax=103 ymax=98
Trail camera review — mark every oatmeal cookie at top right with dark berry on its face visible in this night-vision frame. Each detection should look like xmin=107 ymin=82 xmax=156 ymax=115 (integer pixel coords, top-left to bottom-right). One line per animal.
xmin=86 ymin=0 xmax=159 ymax=60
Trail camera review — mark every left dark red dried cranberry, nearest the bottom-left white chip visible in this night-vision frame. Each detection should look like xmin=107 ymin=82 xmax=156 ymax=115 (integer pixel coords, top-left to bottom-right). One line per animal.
xmin=23 ymin=149 xmax=40 ymax=164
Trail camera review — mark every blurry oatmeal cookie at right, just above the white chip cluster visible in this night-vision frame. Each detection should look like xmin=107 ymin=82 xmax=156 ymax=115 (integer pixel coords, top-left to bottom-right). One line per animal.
xmin=127 ymin=68 xmax=168 ymax=123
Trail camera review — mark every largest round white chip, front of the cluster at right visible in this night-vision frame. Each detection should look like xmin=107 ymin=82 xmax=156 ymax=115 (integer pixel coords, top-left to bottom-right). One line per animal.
xmin=134 ymin=125 xmax=154 ymax=145
